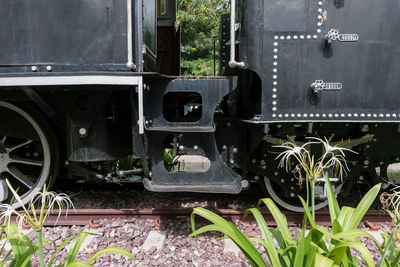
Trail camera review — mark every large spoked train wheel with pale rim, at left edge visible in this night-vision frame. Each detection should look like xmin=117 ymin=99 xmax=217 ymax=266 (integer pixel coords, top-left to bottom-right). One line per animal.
xmin=0 ymin=101 xmax=59 ymax=208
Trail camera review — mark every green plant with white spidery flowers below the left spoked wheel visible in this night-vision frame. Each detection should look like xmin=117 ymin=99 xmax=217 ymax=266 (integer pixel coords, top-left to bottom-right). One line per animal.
xmin=0 ymin=179 xmax=135 ymax=267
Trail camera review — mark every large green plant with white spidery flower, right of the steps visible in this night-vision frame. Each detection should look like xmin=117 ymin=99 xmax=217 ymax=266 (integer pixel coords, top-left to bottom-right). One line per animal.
xmin=190 ymin=139 xmax=380 ymax=267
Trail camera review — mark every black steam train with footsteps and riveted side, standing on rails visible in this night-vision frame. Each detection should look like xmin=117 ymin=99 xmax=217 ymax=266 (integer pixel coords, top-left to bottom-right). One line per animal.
xmin=0 ymin=0 xmax=400 ymax=210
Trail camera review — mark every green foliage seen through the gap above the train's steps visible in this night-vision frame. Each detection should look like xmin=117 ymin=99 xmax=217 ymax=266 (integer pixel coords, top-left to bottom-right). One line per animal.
xmin=177 ymin=0 xmax=229 ymax=76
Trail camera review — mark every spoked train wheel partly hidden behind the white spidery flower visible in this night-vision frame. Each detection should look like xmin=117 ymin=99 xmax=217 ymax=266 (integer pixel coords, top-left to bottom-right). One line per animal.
xmin=264 ymin=176 xmax=342 ymax=212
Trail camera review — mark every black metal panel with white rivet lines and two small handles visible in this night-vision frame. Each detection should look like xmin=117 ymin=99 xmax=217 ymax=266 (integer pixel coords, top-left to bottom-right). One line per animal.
xmin=241 ymin=0 xmax=400 ymax=121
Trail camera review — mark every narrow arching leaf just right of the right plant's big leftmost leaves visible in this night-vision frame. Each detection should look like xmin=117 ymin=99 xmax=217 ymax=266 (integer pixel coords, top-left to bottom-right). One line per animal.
xmin=243 ymin=208 xmax=281 ymax=267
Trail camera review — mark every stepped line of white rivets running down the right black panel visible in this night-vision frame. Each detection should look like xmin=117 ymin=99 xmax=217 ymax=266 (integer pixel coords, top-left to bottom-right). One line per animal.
xmin=272 ymin=1 xmax=324 ymax=117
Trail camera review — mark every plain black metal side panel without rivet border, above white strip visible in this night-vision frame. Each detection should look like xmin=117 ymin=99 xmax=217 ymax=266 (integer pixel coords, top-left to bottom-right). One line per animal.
xmin=0 ymin=0 xmax=131 ymax=72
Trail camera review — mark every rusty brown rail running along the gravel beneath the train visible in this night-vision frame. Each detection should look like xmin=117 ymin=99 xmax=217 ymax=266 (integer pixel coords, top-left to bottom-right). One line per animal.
xmin=10 ymin=208 xmax=391 ymax=226
